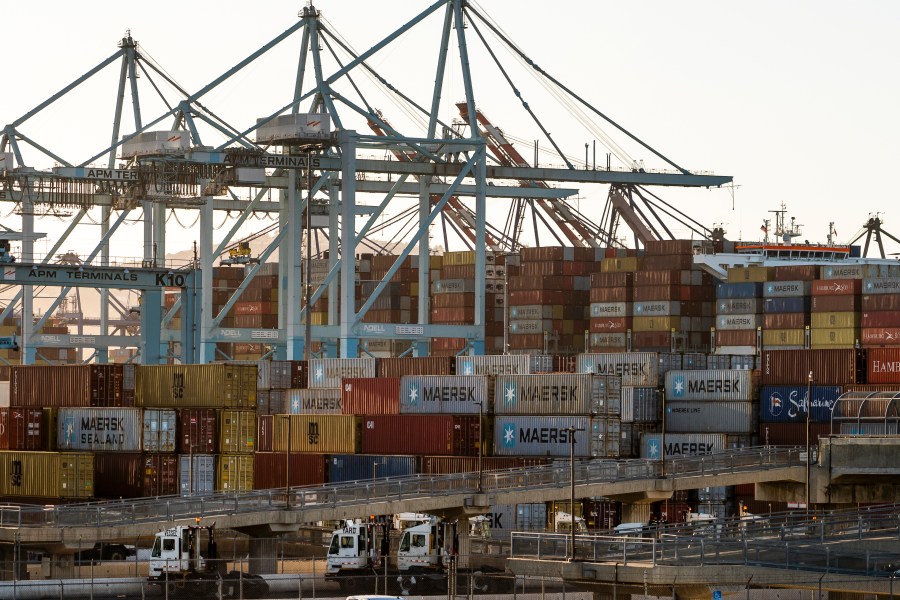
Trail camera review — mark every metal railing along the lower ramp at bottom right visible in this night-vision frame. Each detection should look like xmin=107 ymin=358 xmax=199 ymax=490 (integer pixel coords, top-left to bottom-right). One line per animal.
xmin=510 ymin=504 xmax=900 ymax=577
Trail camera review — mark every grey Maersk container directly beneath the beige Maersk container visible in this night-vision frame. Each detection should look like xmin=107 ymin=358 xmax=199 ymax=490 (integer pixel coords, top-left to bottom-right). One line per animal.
xmin=494 ymin=415 xmax=603 ymax=458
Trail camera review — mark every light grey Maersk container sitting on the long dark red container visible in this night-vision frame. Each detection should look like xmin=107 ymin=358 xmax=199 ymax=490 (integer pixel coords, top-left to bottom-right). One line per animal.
xmin=400 ymin=375 xmax=491 ymax=415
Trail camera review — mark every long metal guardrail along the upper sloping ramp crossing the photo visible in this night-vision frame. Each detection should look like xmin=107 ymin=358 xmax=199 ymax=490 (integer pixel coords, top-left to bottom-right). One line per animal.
xmin=0 ymin=447 xmax=803 ymax=527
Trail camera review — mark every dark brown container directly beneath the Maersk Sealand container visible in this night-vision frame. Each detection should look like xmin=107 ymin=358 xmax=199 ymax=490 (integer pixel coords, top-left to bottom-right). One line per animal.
xmin=94 ymin=452 xmax=178 ymax=499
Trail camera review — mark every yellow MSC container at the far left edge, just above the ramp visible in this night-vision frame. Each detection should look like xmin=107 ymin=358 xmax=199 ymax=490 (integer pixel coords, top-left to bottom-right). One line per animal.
xmin=0 ymin=451 xmax=94 ymax=500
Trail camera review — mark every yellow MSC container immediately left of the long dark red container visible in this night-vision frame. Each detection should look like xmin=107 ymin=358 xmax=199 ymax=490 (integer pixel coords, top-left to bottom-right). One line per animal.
xmin=272 ymin=415 xmax=362 ymax=454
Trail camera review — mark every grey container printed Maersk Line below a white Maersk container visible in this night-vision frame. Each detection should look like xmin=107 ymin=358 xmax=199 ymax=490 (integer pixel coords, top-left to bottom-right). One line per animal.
xmin=665 ymin=400 xmax=759 ymax=434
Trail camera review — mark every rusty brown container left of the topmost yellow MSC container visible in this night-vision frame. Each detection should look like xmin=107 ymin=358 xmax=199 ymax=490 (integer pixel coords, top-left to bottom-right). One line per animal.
xmin=10 ymin=365 xmax=122 ymax=408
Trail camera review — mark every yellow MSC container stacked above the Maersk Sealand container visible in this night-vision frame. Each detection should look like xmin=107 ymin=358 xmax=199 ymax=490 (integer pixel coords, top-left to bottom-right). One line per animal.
xmin=134 ymin=363 xmax=257 ymax=409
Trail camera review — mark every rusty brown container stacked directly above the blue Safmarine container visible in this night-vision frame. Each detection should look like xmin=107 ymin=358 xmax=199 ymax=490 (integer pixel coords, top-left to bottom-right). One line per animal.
xmin=760 ymin=348 xmax=866 ymax=385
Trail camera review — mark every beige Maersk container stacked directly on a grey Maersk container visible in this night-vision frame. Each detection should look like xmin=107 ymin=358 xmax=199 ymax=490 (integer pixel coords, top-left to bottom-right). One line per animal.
xmin=494 ymin=373 xmax=605 ymax=415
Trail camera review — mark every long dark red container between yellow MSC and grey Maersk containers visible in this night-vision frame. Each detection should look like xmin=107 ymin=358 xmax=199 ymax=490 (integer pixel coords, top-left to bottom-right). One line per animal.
xmin=362 ymin=415 xmax=481 ymax=456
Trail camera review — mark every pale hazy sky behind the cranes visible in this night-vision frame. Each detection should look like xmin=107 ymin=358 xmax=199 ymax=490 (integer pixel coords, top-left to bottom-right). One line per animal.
xmin=0 ymin=0 xmax=900 ymax=254
